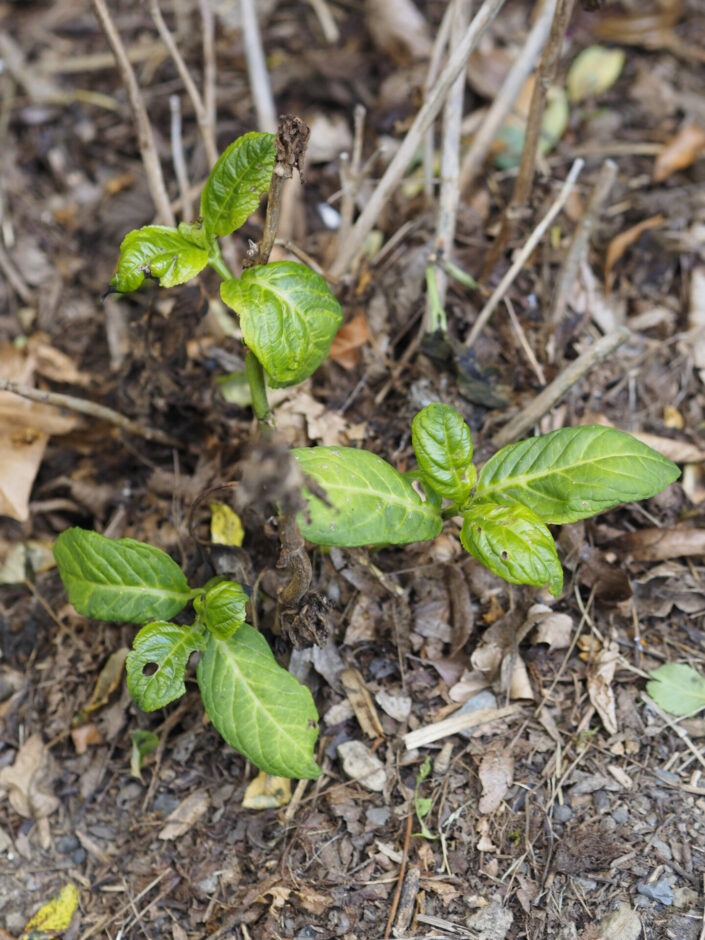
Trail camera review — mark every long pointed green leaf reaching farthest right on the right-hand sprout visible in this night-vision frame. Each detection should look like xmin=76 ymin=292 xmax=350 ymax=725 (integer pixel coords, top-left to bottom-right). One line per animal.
xmin=475 ymin=425 xmax=680 ymax=523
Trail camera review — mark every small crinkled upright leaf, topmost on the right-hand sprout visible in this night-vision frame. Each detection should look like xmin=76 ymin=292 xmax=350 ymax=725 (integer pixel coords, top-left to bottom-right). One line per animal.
xmin=411 ymin=403 xmax=477 ymax=504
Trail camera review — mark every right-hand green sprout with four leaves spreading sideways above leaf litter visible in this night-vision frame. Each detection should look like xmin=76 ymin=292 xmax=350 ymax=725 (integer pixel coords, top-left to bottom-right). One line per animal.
xmin=293 ymin=404 xmax=680 ymax=596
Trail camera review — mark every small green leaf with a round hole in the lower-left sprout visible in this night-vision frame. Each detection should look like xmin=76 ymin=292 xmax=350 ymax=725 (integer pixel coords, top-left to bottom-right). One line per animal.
xmin=126 ymin=620 xmax=206 ymax=712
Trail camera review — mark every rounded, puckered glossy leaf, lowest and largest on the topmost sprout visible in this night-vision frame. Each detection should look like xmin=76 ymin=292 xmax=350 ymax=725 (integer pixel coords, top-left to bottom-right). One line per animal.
xmin=220 ymin=261 xmax=343 ymax=387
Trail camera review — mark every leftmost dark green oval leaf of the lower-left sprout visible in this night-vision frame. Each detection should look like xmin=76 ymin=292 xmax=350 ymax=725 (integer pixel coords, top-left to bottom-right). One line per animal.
xmin=54 ymin=528 xmax=193 ymax=623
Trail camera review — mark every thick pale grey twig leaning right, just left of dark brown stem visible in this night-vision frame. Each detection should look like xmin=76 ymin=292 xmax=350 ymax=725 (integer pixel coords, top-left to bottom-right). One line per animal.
xmin=460 ymin=0 xmax=557 ymax=192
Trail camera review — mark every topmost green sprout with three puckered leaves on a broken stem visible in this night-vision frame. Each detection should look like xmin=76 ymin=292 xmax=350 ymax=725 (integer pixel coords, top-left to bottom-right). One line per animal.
xmin=110 ymin=133 xmax=343 ymax=423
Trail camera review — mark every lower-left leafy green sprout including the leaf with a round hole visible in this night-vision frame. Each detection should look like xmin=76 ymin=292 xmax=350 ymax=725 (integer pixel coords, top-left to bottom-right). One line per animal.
xmin=54 ymin=528 xmax=320 ymax=778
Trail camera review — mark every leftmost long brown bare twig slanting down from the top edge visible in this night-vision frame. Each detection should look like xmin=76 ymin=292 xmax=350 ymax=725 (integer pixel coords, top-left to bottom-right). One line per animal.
xmin=93 ymin=0 xmax=175 ymax=225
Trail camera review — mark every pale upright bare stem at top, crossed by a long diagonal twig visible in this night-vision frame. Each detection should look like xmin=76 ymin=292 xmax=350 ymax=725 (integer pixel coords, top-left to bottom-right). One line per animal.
xmin=426 ymin=0 xmax=470 ymax=333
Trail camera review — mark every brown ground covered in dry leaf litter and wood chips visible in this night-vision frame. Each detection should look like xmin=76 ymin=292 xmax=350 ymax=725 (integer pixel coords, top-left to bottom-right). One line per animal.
xmin=0 ymin=0 xmax=705 ymax=940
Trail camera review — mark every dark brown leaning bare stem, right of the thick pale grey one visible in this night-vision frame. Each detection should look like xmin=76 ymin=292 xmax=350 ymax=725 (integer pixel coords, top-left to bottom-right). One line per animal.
xmin=483 ymin=0 xmax=575 ymax=276
